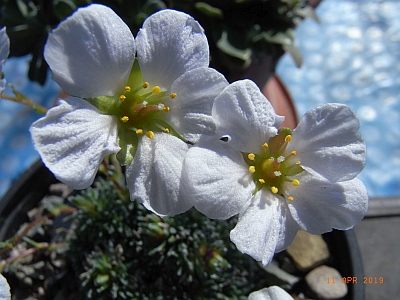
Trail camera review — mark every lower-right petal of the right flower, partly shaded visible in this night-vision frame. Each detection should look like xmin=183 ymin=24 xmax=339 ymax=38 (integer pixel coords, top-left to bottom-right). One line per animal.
xmin=288 ymin=172 xmax=368 ymax=234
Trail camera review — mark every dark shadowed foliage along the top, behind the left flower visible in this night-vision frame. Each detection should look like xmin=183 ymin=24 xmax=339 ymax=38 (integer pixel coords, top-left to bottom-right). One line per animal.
xmin=0 ymin=0 xmax=317 ymax=84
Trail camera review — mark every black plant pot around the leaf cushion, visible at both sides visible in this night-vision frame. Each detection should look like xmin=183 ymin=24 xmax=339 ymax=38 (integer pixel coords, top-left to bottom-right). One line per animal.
xmin=0 ymin=160 xmax=364 ymax=300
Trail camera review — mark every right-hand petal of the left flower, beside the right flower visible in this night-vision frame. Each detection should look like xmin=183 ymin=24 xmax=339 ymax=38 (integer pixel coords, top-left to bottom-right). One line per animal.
xmin=165 ymin=68 xmax=228 ymax=143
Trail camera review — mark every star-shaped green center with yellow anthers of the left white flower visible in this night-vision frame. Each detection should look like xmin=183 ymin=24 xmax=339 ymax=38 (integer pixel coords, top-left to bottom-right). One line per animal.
xmin=86 ymin=61 xmax=183 ymax=164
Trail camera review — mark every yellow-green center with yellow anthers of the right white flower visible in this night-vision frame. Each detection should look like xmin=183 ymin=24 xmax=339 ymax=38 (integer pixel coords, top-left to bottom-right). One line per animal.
xmin=243 ymin=128 xmax=304 ymax=201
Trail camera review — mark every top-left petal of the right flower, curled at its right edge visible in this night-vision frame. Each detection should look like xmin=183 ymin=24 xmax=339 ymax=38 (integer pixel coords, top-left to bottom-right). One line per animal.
xmin=212 ymin=80 xmax=277 ymax=153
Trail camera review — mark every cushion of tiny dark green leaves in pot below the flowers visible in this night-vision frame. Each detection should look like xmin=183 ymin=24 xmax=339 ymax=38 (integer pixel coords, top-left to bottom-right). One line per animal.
xmin=69 ymin=165 xmax=267 ymax=299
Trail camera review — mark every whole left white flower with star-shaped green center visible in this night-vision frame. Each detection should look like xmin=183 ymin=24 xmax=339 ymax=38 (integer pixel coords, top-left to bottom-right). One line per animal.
xmin=31 ymin=4 xmax=227 ymax=215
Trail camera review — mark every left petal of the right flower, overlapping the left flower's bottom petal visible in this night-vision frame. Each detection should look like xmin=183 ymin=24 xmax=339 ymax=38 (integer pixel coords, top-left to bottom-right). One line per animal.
xmin=182 ymin=140 xmax=255 ymax=219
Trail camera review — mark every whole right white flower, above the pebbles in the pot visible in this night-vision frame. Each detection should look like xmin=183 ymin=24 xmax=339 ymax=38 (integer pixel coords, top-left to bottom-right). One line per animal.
xmin=182 ymin=81 xmax=368 ymax=264
